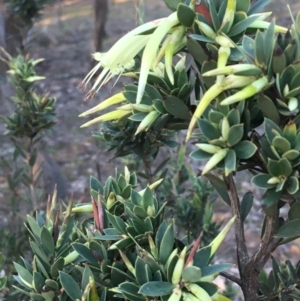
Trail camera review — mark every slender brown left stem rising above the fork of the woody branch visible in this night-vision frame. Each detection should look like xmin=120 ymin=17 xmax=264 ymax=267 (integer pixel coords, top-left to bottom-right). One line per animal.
xmin=225 ymin=174 xmax=249 ymax=270
